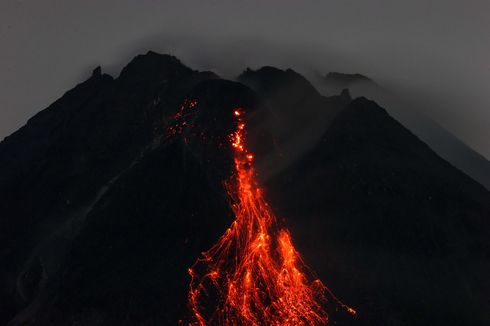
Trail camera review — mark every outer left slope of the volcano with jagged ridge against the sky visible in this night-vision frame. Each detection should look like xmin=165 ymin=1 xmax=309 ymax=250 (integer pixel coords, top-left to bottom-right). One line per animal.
xmin=0 ymin=52 xmax=216 ymax=322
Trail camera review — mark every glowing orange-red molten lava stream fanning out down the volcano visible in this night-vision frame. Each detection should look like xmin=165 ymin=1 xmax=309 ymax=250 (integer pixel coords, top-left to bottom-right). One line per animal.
xmin=189 ymin=108 xmax=355 ymax=326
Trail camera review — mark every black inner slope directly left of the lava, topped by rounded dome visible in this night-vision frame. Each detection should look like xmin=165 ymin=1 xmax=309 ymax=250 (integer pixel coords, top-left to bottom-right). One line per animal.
xmin=7 ymin=80 xmax=257 ymax=325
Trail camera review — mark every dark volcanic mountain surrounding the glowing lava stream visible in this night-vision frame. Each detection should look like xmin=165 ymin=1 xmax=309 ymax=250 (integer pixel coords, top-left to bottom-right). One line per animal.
xmin=0 ymin=52 xmax=490 ymax=325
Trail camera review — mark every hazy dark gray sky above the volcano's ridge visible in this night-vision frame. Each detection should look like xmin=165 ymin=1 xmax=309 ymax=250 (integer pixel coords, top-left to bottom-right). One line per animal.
xmin=0 ymin=0 xmax=490 ymax=158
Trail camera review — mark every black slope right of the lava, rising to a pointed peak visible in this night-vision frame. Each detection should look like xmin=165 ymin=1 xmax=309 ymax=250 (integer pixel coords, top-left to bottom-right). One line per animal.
xmin=266 ymin=98 xmax=490 ymax=325
